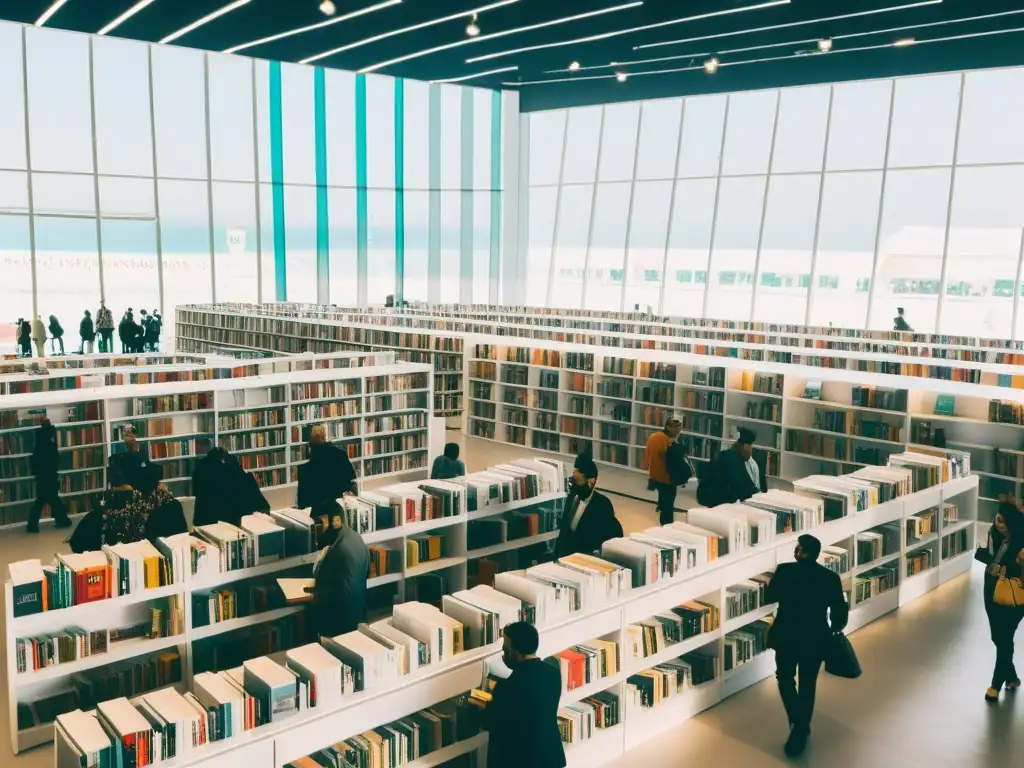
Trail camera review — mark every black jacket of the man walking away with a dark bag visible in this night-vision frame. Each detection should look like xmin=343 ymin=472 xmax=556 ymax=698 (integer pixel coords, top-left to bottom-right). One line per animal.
xmin=765 ymin=560 xmax=850 ymax=653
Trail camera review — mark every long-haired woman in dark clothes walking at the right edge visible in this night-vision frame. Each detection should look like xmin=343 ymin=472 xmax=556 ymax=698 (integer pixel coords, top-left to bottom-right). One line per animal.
xmin=974 ymin=501 xmax=1024 ymax=702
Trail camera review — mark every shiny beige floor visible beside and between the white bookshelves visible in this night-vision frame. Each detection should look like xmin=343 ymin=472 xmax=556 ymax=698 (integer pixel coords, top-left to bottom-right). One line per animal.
xmin=0 ymin=432 xmax=1024 ymax=768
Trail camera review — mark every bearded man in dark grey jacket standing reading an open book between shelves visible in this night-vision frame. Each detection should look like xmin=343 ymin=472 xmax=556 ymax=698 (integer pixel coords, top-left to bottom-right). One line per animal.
xmin=307 ymin=500 xmax=370 ymax=637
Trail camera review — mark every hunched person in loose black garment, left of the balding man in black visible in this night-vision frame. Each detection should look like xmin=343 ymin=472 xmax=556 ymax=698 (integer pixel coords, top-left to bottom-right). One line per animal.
xmin=191 ymin=437 xmax=270 ymax=525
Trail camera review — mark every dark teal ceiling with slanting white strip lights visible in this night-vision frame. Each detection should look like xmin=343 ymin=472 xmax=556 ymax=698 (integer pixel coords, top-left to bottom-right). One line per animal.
xmin=6 ymin=0 xmax=1024 ymax=111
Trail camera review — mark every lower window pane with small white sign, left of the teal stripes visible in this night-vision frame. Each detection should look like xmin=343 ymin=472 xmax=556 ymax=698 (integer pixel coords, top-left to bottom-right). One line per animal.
xmin=213 ymin=181 xmax=259 ymax=302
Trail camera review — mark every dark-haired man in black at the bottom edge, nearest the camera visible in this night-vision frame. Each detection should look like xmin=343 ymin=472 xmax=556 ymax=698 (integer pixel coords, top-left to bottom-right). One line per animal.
xmin=484 ymin=622 xmax=565 ymax=768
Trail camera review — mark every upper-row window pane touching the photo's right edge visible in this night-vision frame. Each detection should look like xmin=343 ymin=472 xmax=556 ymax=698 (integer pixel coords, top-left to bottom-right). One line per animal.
xmin=954 ymin=68 xmax=1024 ymax=163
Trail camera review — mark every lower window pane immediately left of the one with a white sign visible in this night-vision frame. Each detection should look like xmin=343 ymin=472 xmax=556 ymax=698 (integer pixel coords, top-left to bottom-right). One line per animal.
xmin=159 ymin=179 xmax=211 ymax=317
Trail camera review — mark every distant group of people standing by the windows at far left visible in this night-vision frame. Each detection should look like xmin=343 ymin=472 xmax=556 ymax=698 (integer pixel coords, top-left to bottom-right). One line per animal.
xmin=14 ymin=301 xmax=164 ymax=357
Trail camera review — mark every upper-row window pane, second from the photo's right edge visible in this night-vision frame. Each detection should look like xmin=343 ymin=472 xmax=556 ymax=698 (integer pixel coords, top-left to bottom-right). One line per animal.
xmin=889 ymin=75 xmax=961 ymax=168
